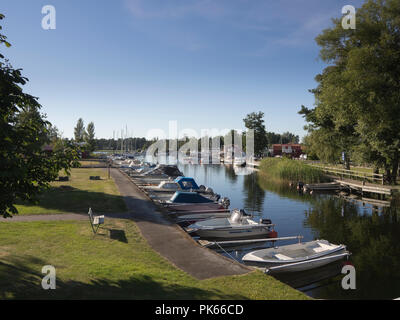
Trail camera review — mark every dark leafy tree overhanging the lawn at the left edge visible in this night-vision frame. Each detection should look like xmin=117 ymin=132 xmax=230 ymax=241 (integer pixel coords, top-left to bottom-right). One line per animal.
xmin=0 ymin=14 xmax=77 ymax=217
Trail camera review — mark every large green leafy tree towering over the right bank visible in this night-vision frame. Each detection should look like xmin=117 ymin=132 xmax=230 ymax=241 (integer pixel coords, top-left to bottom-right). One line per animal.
xmin=300 ymin=0 xmax=400 ymax=183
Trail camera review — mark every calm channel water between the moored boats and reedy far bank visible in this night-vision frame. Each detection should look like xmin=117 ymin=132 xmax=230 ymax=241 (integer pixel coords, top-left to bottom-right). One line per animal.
xmin=148 ymin=158 xmax=400 ymax=299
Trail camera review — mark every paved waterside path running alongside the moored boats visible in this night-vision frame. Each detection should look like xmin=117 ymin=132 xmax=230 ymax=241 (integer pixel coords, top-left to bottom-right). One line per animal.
xmin=111 ymin=169 xmax=251 ymax=279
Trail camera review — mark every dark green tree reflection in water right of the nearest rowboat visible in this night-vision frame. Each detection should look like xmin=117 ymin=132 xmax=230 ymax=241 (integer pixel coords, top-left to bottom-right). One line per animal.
xmin=305 ymin=197 xmax=400 ymax=299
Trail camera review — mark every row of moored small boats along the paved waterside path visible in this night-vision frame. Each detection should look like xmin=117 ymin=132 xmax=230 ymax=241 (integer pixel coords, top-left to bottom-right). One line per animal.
xmin=114 ymin=159 xmax=350 ymax=272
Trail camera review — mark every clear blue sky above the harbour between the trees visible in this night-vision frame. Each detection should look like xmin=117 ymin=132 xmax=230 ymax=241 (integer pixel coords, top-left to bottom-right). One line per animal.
xmin=0 ymin=0 xmax=362 ymax=138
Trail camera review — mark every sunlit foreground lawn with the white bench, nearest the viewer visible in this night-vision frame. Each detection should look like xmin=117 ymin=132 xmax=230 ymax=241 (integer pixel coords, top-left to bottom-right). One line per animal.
xmin=0 ymin=219 xmax=308 ymax=299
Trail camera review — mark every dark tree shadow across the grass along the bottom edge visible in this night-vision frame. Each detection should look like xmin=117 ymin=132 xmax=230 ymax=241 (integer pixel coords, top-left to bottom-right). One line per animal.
xmin=0 ymin=257 xmax=246 ymax=300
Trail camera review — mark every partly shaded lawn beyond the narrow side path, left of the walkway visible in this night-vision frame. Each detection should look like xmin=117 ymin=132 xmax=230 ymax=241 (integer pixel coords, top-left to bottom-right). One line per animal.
xmin=16 ymin=168 xmax=126 ymax=215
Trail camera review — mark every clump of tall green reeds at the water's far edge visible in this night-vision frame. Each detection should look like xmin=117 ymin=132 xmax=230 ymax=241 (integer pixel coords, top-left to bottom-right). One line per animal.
xmin=260 ymin=158 xmax=329 ymax=183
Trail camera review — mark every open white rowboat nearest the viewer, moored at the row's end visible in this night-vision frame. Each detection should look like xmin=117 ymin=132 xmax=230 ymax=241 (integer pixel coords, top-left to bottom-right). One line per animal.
xmin=242 ymin=240 xmax=350 ymax=273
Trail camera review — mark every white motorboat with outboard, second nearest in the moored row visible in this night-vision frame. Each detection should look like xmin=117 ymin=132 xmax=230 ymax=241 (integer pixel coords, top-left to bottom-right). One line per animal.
xmin=188 ymin=209 xmax=273 ymax=239
